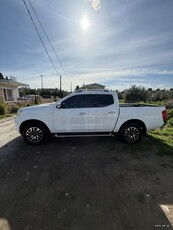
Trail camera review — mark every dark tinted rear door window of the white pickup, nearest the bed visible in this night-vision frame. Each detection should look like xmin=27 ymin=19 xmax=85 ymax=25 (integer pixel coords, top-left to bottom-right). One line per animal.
xmin=91 ymin=94 xmax=114 ymax=107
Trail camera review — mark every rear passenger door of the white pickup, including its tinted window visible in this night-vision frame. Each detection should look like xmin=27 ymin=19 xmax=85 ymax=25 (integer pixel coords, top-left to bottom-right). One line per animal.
xmin=88 ymin=94 xmax=118 ymax=132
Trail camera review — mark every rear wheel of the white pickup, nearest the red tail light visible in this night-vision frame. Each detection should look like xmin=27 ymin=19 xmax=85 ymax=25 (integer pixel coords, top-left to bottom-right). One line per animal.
xmin=120 ymin=123 xmax=142 ymax=144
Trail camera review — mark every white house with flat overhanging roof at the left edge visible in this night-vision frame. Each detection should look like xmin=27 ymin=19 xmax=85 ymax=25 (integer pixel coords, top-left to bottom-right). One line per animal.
xmin=0 ymin=78 xmax=28 ymax=101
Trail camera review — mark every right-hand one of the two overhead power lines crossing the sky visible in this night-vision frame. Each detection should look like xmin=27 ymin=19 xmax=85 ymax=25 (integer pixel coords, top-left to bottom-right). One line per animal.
xmin=28 ymin=0 xmax=71 ymax=83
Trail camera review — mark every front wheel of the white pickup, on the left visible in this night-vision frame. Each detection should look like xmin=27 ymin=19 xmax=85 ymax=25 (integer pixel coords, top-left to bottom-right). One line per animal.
xmin=22 ymin=122 xmax=50 ymax=145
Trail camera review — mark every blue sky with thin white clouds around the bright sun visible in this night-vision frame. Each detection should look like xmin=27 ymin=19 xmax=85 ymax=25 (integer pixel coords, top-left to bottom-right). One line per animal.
xmin=0 ymin=0 xmax=173 ymax=90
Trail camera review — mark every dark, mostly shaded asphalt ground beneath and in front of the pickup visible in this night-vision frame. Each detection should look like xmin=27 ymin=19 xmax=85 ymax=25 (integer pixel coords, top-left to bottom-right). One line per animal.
xmin=0 ymin=117 xmax=173 ymax=230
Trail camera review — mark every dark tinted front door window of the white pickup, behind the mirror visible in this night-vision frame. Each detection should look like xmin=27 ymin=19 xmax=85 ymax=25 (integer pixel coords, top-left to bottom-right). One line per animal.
xmin=62 ymin=95 xmax=91 ymax=109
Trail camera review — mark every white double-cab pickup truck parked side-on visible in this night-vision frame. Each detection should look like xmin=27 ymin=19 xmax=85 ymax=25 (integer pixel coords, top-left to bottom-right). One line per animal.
xmin=16 ymin=90 xmax=166 ymax=145
